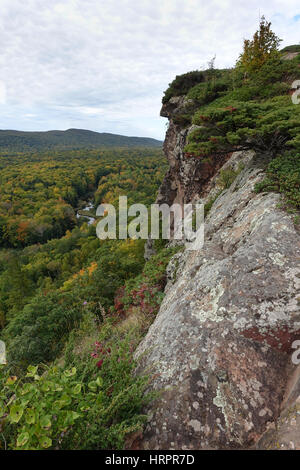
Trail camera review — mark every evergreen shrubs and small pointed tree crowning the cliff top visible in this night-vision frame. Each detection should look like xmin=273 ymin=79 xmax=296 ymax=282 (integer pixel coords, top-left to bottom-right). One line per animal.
xmin=163 ymin=17 xmax=300 ymax=209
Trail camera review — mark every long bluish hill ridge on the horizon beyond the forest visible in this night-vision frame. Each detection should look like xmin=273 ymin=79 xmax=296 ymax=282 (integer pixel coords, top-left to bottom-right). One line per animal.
xmin=0 ymin=129 xmax=162 ymax=152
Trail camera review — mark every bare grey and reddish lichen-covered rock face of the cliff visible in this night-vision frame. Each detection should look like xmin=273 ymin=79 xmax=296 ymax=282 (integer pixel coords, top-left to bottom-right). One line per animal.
xmin=137 ymin=97 xmax=300 ymax=449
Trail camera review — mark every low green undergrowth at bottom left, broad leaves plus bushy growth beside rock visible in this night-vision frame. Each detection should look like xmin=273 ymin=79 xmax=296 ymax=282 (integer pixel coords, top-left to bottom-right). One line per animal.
xmin=0 ymin=329 xmax=149 ymax=450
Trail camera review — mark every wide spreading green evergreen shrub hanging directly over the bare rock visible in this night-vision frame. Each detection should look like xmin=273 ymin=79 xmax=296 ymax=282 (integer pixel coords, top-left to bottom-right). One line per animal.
xmin=185 ymin=96 xmax=300 ymax=157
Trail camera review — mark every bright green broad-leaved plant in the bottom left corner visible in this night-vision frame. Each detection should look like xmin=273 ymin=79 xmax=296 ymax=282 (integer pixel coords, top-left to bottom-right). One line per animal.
xmin=0 ymin=366 xmax=89 ymax=450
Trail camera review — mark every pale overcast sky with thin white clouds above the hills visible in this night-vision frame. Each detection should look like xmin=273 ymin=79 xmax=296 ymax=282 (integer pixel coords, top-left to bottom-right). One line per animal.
xmin=0 ymin=0 xmax=300 ymax=139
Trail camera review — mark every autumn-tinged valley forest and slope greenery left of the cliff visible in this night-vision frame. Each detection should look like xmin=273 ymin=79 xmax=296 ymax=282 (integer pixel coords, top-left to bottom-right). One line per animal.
xmin=0 ymin=149 xmax=182 ymax=448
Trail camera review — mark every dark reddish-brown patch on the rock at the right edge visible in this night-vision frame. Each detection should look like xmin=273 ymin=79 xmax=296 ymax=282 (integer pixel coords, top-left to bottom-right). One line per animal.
xmin=241 ymin=326 xmax=300 ymax=353
